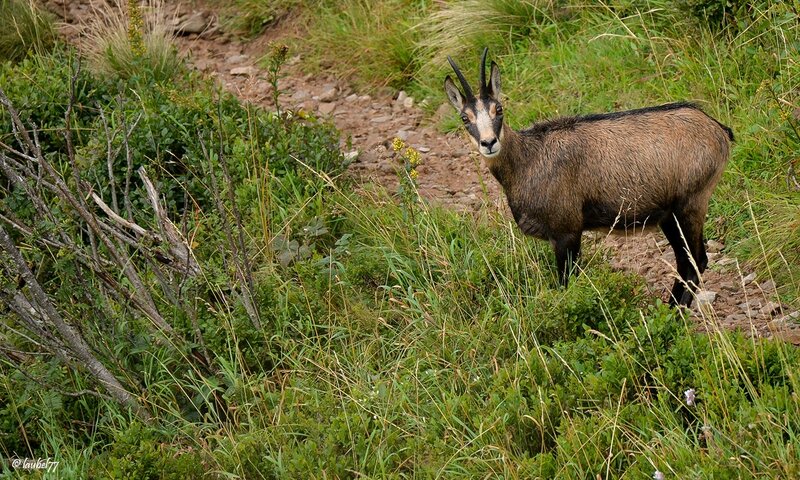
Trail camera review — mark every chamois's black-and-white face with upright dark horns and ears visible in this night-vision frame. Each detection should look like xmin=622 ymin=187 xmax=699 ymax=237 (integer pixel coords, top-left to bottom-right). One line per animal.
xmin=444 ymin=48 xmax=503 ymax=158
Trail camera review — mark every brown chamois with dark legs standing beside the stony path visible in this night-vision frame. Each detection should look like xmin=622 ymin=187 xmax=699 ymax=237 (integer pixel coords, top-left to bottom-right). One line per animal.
xmin=444 ymin=49 xmax=733 ymax=306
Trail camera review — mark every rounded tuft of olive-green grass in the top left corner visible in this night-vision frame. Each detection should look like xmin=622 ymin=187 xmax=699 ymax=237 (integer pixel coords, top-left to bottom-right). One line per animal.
xmin=0 ymin=0 xmax=56 ymax=61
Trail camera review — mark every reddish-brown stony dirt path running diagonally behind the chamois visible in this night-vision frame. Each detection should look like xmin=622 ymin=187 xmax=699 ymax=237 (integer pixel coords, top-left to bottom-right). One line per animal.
xmin=46 ymin=0 xmax=800 ymax=344
